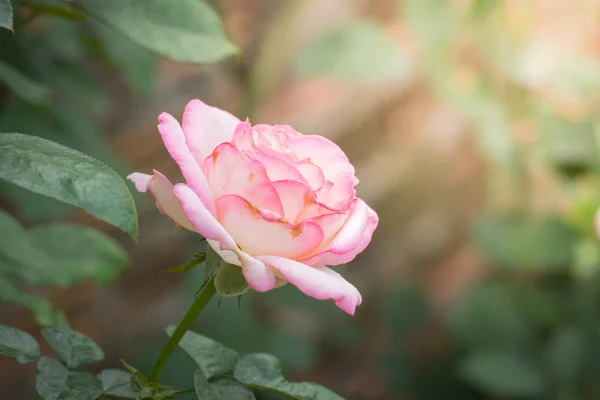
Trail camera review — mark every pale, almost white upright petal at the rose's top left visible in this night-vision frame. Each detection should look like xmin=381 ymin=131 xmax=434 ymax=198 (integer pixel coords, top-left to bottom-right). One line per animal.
xmin=182 ymin=99 xmax=240 ymax=166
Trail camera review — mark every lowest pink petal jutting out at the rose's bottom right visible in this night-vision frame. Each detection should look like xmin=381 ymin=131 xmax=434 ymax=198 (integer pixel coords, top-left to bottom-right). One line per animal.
xmin=257 ymin=256 xmax=362 ymax=315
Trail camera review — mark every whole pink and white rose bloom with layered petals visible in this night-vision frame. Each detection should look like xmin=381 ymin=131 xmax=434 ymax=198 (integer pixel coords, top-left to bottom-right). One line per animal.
xmin=128 ymin=100 xmax=379 ymax=315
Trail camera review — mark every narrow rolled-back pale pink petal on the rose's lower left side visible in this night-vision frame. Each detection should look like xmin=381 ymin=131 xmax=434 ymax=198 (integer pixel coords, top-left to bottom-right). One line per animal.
xmin=173 ymin=183 xmax=237 ymax=250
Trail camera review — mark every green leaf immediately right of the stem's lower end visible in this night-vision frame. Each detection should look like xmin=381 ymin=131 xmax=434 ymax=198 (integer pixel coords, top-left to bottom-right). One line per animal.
xmin=166 ymin=326 xmax=238 ymax=379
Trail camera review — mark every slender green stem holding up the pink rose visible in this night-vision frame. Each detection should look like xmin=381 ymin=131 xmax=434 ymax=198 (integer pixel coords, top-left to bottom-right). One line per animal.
xmin=148 ymin=279 xmax=216 ymax=383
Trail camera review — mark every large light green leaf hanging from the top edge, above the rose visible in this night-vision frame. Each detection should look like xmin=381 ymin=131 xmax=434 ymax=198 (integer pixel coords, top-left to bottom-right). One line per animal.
xmin=76 ymin=0 xmax=238 ymax=63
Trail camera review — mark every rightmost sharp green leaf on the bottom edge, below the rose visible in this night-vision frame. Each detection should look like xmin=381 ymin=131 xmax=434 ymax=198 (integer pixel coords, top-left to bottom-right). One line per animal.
xmin=233 ymin=353 xmax=343 ymax=400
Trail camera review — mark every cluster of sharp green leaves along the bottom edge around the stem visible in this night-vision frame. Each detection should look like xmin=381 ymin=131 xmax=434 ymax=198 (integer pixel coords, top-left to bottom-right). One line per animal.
xmin=0 ymin=325 xmax=340 ymax=400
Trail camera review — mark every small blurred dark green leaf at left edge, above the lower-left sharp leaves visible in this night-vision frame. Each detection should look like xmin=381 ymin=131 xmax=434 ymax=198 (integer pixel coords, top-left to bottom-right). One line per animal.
xmin=0 ymin=274 xmax=67 ymax=326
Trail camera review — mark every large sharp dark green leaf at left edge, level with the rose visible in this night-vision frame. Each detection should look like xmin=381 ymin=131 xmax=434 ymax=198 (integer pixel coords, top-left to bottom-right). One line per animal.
xmin=0 ymin=133 xmax=138 ymax=240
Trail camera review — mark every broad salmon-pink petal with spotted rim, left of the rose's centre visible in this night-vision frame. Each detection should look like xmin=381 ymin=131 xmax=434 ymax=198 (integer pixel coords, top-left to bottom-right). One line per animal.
xmin=205 ymin=143 xmax=283 ymax=216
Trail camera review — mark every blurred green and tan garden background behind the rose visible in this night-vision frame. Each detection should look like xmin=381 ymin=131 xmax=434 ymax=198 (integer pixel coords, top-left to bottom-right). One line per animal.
xmin=0 ymin=0 xmax=600 ymax=400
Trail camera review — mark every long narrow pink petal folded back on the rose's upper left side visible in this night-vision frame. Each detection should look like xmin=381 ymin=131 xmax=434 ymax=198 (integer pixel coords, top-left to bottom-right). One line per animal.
xmin=158 ymin=113 xmax=215 ymax=214
